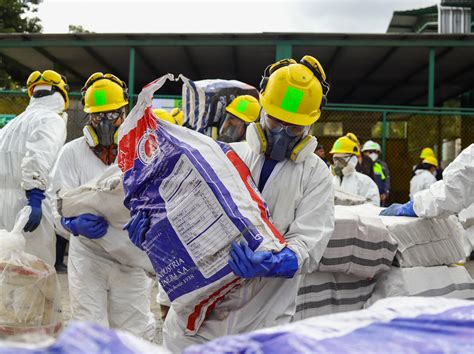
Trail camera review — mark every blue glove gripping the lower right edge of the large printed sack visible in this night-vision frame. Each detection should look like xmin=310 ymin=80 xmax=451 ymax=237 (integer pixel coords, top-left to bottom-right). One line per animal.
xmin=229 ymin=240 xmax=298 ymax=278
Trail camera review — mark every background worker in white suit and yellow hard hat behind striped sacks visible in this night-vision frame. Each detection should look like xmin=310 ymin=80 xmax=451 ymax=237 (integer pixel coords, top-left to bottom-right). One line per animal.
xmin=330 ymin=136 xmax=380 ymax=206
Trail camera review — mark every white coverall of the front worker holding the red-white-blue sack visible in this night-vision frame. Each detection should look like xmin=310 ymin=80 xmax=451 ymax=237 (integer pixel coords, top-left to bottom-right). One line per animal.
xmin=163 ymin=142 xmax=334 ymax=353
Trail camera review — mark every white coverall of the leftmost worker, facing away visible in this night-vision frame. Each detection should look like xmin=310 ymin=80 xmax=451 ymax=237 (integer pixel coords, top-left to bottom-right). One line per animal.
xmin=0 ymin=92 xmax=66 ymax=266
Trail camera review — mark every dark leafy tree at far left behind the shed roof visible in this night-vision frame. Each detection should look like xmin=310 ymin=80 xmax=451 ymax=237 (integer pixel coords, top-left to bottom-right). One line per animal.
xmin=0 ymin=0 xmax=43 ymax=89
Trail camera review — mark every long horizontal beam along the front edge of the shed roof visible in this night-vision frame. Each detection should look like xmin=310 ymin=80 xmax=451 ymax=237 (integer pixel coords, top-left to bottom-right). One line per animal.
xmin=0 ymin=36 xmax=474 ymax=48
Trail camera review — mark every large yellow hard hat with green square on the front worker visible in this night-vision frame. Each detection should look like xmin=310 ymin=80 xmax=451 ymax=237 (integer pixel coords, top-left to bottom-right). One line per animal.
xmin=260 ymin=55 xmax=329 ymax=126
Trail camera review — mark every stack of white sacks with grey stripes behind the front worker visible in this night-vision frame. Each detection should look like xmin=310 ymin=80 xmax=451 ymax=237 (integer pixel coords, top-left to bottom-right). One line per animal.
xmin=295 ymin=191 xmax=474 ymax=320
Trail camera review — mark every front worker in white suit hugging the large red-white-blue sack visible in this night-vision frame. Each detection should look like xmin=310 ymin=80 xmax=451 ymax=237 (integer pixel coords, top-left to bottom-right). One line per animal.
xmin=129 ymin=56 xmax=334 ymax=353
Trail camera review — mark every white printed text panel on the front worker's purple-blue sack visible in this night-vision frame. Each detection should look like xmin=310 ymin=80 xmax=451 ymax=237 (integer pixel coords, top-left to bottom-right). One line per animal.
xmin=160 ymin=154 xmax=240 ymax=278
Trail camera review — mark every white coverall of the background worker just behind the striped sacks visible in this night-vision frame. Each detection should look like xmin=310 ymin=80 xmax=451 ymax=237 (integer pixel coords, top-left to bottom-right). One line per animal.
xmin=333 ymin=171 xmax=380 ymax=206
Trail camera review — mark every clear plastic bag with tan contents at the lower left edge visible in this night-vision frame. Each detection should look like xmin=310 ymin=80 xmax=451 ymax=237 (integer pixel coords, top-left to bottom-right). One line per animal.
xmin=0 ymin=207 xmax=62 ymax=336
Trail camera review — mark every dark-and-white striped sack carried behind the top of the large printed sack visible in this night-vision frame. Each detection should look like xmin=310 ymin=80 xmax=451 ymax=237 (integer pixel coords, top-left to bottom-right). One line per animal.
xmin=179 ymin=75 xmax=259 ymax=137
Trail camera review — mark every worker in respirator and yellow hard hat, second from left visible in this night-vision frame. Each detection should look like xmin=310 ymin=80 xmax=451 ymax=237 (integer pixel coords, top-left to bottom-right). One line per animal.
xmin=53 ymin=73 xmax=155 ymax=340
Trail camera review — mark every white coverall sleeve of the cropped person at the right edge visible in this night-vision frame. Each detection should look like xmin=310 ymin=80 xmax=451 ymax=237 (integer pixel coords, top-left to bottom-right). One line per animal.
xmin=413 ymin=144 xmax=474 ymax=254
